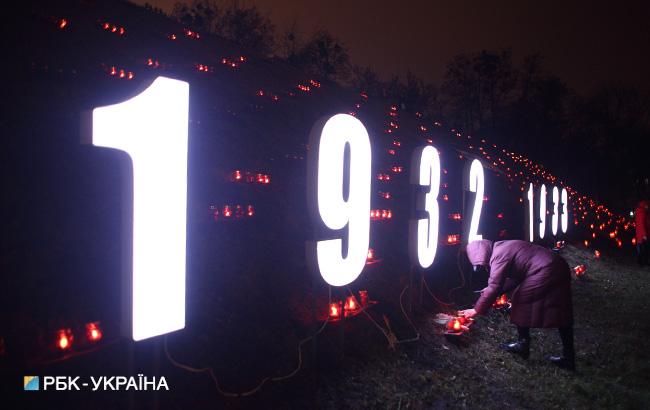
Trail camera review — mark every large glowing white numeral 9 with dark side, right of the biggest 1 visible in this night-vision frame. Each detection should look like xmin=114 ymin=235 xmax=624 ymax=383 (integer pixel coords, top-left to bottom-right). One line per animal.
xmin=307 ymin=114 xmax=371 ymax=286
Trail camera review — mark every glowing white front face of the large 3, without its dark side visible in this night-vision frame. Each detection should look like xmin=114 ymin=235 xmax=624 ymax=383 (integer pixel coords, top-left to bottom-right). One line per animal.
xmin=417 ymin=145 xmax=440 ymax=269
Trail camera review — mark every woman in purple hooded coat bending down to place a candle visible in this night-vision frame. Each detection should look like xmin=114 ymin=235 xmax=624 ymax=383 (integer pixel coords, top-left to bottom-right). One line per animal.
xmin=461 ymin=239 xmax=575 ymax=370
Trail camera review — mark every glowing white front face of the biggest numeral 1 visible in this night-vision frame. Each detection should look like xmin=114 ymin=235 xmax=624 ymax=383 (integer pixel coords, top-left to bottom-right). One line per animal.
xmin=92 ymin=77 xmax=189 ymax=340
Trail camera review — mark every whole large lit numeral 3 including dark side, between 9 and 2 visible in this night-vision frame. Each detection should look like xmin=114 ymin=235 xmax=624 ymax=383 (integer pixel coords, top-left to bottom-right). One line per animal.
xmin=409 ymin=146 xmax=440 ymax=269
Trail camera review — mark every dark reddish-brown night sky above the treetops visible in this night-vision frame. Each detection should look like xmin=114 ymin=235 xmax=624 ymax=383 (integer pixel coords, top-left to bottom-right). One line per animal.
xmin=136 ymin=0 xmax=650 ymax=95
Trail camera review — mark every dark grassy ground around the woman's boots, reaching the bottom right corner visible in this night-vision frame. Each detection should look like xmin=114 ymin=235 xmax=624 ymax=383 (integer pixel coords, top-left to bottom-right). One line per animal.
xmin=230 ymin=246 xmax=650 ymax=409
